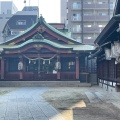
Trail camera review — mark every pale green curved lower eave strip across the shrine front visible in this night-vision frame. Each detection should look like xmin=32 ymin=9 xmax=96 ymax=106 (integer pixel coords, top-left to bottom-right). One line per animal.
xmin=0 ymin=38 xmax=95 ymax=51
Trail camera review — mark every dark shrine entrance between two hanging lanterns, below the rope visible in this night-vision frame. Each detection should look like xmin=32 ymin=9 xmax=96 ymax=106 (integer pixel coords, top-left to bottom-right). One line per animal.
xmin=25 ymin=56 xmax=57 ymax=80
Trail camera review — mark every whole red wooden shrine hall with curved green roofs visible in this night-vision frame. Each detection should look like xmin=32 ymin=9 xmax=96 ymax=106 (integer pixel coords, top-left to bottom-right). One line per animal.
xmin=0 ymin=16 xmax=94 ymax=81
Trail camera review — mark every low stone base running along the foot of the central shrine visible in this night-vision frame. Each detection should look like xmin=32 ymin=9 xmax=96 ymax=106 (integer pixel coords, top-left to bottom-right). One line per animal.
xmin=0 ymin=81 xmax=91 ymax=87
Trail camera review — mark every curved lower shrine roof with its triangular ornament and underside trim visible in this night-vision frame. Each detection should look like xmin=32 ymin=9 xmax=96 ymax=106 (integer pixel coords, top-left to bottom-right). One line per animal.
xmin=0 ymin=33 xmax=95 ymax=53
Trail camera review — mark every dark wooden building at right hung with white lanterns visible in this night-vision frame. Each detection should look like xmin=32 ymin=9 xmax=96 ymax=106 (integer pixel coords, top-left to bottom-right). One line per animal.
xmin=90 ymin=1 xmax=120 ymax=89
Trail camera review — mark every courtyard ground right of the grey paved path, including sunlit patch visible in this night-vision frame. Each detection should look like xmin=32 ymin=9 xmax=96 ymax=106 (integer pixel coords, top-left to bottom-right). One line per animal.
xmin=42 ymin=86 xmax=120 ymax=120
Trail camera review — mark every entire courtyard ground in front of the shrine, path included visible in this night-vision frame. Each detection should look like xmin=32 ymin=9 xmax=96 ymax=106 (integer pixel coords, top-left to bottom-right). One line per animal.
xmin=0 ymin=87 xmax=120 ymax=120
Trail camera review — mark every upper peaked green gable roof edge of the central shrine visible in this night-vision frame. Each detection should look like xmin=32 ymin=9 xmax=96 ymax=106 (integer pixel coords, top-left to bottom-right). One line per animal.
xmin=3 ymin=16 xmax=80 ymax=45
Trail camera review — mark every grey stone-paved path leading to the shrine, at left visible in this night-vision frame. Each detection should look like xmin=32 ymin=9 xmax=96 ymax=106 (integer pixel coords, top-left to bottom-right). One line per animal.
xmin=0 ymin=87 xmax=61 ymax=120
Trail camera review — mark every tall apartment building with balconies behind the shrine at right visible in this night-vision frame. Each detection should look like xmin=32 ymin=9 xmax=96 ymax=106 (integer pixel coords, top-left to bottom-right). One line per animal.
xmin=61 ymin=0 xmax=116 ymax=44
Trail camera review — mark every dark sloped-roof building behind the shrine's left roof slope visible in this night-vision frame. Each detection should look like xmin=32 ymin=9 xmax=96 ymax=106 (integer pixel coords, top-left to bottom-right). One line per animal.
xmin=1 ymin=6 xmax=39 ymax=42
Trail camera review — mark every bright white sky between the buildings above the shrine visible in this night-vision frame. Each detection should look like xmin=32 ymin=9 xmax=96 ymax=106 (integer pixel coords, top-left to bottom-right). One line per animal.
xmin=0 ymin=0 xmax=60 ymax=23
